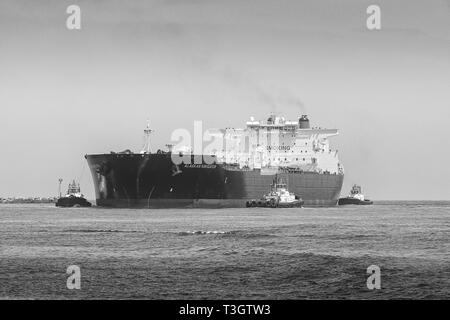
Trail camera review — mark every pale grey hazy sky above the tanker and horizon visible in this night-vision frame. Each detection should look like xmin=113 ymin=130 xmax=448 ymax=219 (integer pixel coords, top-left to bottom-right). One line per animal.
xmin=0 ymin=0 xmax=450 ymax=200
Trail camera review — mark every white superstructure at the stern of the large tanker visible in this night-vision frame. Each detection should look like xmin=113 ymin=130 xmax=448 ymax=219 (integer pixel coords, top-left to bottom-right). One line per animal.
xmin=212 ymin=115 xmax=343 ymax=174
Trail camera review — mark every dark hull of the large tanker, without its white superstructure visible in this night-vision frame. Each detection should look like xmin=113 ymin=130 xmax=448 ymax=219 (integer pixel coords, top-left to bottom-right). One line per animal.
xmin=86 ymin=153 xmax=344 ymax=208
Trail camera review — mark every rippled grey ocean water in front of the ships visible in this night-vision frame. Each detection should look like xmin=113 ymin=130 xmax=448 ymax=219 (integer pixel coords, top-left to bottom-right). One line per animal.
xmin=0 ymin=202 xmax=450 ymax=299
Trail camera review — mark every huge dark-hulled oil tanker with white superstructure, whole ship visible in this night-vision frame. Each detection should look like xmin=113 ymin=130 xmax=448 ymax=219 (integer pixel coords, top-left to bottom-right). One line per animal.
xmin=85 ymin=115 xmax=344 ymax=208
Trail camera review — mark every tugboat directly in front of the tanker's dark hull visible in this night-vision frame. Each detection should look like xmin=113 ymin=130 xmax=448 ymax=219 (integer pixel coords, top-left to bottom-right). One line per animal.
xmin=245 ymin=179 xmax=304 ymax=208
